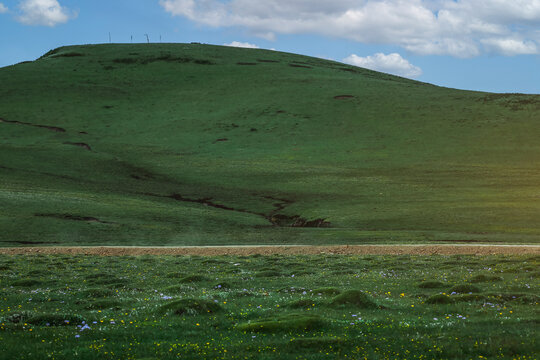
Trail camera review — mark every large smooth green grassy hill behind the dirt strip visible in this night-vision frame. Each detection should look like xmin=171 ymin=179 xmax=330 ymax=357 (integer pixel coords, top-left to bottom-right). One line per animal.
xmin=0 ymin=44 xmax=540 ymax=246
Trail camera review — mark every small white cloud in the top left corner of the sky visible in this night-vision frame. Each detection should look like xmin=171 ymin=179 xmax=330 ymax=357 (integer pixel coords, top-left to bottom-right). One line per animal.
xmin=17 ymin=0 xmax=76 ymax=27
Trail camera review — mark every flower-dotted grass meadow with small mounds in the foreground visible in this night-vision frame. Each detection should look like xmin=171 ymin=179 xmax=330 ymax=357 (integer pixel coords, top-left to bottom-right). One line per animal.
xmin=0 ymin=255 xmax=540 ymax=360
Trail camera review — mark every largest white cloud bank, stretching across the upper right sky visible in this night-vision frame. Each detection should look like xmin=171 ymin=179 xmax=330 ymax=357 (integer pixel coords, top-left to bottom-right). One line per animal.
xmin=160 ymin=0 xmax=540 ymax=57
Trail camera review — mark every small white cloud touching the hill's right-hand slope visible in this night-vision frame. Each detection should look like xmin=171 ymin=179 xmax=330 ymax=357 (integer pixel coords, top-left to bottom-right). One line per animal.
xmin=343 ymin=53 xmax=422 ymax=78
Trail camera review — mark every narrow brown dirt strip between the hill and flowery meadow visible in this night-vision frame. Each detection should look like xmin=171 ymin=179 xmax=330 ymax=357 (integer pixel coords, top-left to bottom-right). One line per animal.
xmin=0 ymin=245 xmax=540 ymax=256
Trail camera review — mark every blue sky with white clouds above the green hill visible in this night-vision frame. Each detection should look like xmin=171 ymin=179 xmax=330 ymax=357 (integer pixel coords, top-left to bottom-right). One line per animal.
xmin=0 ymin=0 xmax=540 ymax=94
